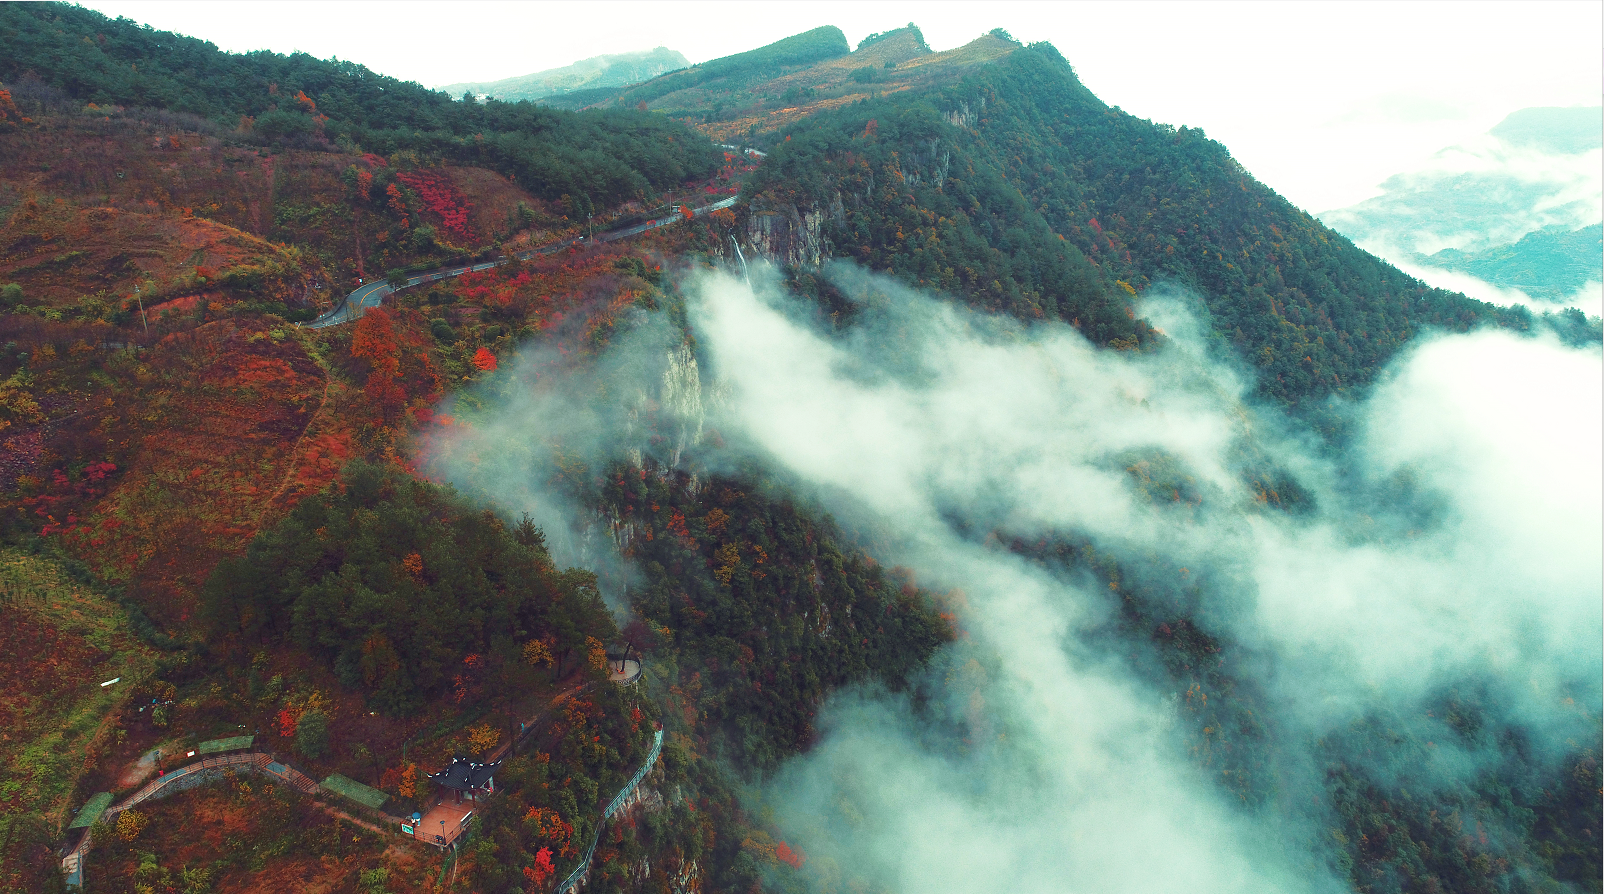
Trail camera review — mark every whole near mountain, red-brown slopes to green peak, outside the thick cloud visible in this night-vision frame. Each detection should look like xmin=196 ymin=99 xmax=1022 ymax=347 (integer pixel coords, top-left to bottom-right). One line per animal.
xmin=0 ymin=3 xmax=1601 ymax=892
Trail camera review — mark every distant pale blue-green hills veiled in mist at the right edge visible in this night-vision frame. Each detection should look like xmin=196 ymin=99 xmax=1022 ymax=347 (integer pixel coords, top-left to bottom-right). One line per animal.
xmin=1320 ymin=108 xmax=1604 ymax=302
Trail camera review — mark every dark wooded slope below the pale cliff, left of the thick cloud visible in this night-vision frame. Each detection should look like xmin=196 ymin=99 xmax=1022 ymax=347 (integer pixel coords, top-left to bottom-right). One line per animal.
xmin=600 ymin=469 xmax=953 ymax=769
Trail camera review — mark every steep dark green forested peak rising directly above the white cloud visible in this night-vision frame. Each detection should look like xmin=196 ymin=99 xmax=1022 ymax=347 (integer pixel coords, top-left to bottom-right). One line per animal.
xmin=696 ymin=39 xmax=1559 ymax=404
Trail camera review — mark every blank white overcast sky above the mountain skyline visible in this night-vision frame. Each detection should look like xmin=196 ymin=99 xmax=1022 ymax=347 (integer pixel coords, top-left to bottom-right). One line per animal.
xmin=85 ymin=0 xmax=1604 ymax=212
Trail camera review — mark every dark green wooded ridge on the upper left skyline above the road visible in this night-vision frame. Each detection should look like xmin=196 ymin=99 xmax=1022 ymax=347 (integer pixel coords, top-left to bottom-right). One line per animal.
xmin=0 ymin=3 xmax=717 ymax=213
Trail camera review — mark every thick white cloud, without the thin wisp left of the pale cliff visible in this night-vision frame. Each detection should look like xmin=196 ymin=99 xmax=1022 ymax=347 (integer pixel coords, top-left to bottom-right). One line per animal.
xmin=691 ymin=271 xmax=1604 ymax=892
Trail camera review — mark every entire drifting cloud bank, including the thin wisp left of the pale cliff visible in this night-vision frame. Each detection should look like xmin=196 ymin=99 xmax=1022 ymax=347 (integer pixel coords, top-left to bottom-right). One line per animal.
xmin=433 ymin=265 xmax=1604 ymax=894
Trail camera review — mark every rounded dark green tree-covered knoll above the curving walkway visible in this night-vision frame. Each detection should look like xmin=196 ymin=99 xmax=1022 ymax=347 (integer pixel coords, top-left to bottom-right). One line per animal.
xmin=204 ymin=462 xmax=616 ymax=714
